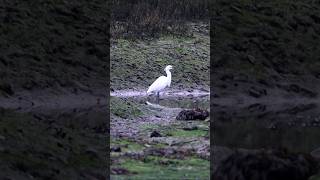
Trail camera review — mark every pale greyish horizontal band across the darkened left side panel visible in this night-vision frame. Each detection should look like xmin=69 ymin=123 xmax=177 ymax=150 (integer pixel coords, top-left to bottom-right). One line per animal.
xmin=0 ymin=90 xmax=107 ymax=112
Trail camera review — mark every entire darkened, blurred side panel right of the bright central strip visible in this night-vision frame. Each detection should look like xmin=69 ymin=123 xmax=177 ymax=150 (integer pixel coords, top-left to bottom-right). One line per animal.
xmin=210 ymin=0 xmax=320 ymax=179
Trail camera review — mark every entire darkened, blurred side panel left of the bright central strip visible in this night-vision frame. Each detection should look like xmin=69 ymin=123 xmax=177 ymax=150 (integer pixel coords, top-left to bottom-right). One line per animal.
xmin=0 ymin=0 xmax=109 ymax=179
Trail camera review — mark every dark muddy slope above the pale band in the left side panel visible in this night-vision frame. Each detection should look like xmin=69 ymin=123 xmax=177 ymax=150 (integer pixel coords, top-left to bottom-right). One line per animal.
xmin=0 ymin=1 xmax=109 ymax=97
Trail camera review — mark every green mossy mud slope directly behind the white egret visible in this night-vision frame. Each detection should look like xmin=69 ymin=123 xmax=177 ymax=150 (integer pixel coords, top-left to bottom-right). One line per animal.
xmin=110 ymin=23 xmax=210 ymax=89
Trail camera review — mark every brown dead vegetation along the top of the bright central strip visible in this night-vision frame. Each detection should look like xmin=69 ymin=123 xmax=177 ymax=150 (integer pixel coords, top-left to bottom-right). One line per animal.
xmin=110 ymin=0 xmax=209 ymax=38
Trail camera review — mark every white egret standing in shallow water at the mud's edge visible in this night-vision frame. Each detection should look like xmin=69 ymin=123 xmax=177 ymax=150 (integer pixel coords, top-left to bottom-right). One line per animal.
xmin=147 ymin=65 xmax=172 ymax=99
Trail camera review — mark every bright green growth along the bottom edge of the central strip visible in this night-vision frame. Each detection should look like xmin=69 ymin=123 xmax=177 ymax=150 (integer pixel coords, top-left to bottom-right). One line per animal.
xmin=111 ymin=156 xmax=210 ymax=180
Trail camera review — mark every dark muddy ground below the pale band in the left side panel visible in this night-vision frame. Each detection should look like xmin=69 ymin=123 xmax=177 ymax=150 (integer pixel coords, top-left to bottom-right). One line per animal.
xmin=0 ymin=106 xmax=108 ymax=179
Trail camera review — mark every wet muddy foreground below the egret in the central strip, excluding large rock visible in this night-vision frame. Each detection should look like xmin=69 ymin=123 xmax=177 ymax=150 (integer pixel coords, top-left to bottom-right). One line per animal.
xmin=110 ymin=95 xmax=210 ymax=179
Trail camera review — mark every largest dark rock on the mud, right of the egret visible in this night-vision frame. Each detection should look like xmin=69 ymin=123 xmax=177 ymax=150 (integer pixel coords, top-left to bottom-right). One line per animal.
xmin=176 ymin=108 xmax=209 ymax=120
